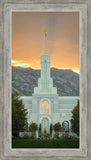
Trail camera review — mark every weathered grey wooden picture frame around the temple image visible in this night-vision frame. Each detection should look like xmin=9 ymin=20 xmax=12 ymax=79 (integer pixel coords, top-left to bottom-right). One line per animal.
xmin=0 ymin=0 xmax=91 ymax=160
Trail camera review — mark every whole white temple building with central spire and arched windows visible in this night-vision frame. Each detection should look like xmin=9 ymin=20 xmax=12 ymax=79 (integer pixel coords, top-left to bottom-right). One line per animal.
xmin=21 ymin=32 xmax=79 ymax=133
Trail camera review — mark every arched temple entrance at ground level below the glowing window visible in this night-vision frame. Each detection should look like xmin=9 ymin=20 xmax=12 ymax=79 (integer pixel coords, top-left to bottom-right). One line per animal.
xmin=41 ymin=118 xmax=50 ymax=134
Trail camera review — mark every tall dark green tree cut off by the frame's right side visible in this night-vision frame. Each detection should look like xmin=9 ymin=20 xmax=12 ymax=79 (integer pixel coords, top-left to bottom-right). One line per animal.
xmin=70 ymin=101 xmax=79 ymax=135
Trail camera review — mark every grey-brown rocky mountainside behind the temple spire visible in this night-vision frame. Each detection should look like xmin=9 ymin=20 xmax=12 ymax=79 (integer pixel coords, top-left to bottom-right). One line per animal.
xmin=12 ymin=67 xmax=79 ymax=96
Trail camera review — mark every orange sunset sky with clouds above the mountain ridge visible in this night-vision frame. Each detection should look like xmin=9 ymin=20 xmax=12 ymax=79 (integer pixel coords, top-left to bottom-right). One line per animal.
xmin=12 ymin=12 xmax=79 ymax=72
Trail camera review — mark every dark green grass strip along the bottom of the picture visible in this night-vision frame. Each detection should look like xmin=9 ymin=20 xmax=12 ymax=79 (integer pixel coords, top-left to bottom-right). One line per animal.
xmin=12 ymin=138 xmax=79 ymax=148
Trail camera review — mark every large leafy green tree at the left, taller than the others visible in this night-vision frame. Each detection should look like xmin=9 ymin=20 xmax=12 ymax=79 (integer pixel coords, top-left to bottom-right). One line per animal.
xmin=12 ymin=92 xmax=27 ymax=136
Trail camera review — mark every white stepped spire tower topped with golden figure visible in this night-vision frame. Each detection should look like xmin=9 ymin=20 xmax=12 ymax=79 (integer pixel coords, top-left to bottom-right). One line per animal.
xmin=34 ymin=30 xmax=57 ymax=94
